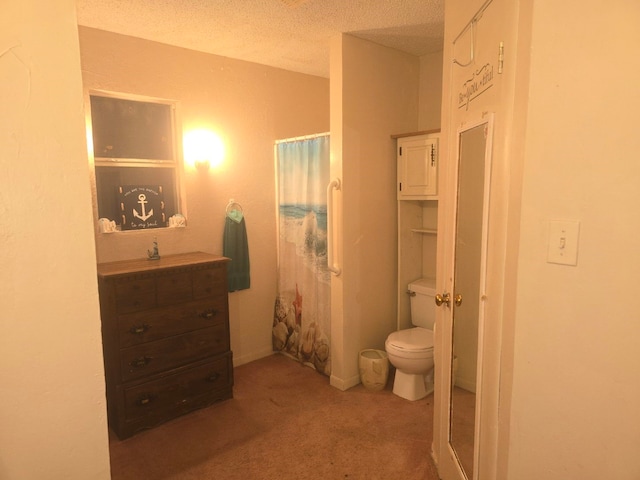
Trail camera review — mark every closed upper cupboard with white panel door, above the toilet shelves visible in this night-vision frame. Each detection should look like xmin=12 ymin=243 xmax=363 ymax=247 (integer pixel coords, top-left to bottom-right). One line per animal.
xmin=397 ymin=134 xmax=438 ymax=200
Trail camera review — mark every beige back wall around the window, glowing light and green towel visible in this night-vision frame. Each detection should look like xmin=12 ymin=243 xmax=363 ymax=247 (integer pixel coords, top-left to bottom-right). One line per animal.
xmin=80 ymin=27 xmax=329 ymax=365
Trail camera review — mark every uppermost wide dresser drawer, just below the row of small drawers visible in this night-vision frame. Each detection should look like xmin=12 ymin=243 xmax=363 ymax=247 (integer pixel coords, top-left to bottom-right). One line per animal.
xmin=118 ymin=295 xmax=229 ymax=348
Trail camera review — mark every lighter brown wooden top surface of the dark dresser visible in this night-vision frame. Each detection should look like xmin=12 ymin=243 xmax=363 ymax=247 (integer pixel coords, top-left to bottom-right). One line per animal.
xmin=98 ymin=252 xmax=229 ymax=277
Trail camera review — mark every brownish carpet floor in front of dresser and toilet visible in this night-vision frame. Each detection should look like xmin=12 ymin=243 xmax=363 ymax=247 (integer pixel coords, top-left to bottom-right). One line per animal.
xmin=110 ymin=355 xmax=438 ymax=480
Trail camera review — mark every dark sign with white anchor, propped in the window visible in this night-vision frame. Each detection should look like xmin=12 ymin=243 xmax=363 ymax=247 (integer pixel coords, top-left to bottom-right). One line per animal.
xmin=116 ymin=185 xmax=167 ymax=230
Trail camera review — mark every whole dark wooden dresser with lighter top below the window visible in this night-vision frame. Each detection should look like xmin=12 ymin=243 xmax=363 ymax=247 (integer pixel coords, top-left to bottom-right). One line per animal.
xmin=98 ymin=252 xmax=233 ymax=438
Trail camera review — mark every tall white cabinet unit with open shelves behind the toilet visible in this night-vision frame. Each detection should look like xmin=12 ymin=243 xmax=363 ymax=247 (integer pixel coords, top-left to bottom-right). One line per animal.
xmin=396 ymin=134 xmax=438 ymax=329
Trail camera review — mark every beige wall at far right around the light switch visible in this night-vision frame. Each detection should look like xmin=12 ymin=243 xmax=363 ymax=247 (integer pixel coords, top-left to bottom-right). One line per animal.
xmin=504 ymin=0 xmax=640 ymax=480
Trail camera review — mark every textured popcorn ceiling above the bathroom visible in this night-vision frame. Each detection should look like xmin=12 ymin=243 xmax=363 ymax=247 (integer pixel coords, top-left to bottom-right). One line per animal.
xmin=77 ymin=0 xmax=444 ymax=78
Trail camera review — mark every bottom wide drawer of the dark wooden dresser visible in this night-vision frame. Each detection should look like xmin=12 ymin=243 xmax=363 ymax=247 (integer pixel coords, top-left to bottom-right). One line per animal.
xmin=124 ymin=355 xmax=233 ymax=420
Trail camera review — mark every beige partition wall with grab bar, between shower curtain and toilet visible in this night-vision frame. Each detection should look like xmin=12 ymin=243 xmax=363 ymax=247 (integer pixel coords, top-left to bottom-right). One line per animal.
xmin=331 ymin=35 xmax=420 ymax=389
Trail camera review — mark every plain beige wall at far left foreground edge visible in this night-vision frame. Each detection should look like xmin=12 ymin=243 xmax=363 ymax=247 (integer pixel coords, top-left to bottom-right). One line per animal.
xmin=0 ymin=0 xmax=110 ymax=480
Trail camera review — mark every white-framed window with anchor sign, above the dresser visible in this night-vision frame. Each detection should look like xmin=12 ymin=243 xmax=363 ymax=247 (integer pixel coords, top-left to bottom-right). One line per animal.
xmin=90 ymin=93 xmax=180 ymax=230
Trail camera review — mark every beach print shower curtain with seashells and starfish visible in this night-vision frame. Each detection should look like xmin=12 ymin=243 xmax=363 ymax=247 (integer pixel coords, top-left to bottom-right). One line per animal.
xmin=273 ymin=134 xmax=331 ymax=375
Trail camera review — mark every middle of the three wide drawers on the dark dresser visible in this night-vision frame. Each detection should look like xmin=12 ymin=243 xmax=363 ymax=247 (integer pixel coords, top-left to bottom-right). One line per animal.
xmin=120 ymin=323 xmax=229 ymax=382
